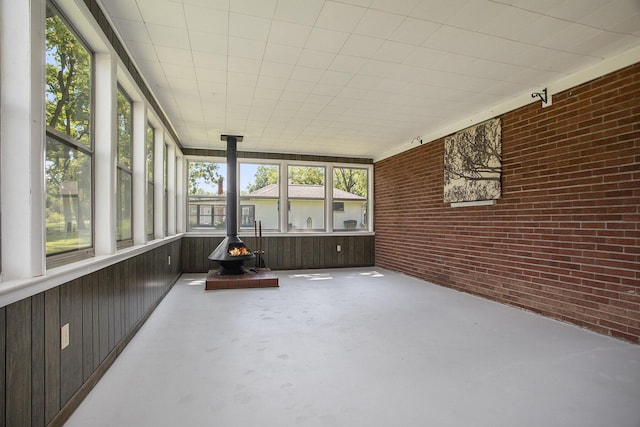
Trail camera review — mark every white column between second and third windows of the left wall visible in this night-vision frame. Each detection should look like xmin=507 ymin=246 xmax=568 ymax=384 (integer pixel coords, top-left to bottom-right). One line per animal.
xmin=132 ymin=102 xmax=147 ymax=245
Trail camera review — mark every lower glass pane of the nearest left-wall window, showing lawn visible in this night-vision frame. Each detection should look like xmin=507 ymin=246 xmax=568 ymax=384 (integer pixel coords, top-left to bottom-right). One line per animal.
xmin=45 ymin=137 xmax=93 ymax=255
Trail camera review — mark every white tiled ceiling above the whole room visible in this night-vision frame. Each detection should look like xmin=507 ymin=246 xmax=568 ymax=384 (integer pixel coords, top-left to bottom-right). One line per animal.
xmin=100 ymin=0 xmax=640 ymax=158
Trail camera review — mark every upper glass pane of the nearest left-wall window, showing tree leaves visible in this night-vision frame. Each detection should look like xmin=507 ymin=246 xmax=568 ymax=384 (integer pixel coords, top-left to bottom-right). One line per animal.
xmin=45 ymin=4 xmax=91 ymax=146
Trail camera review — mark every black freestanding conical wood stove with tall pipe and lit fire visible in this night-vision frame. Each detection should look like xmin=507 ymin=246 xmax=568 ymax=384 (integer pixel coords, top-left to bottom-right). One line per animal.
xmin=208 ymin=135 xmax=255 ymax=275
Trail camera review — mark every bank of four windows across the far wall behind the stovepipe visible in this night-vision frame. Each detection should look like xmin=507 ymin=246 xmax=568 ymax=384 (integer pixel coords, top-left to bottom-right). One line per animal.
xmin=187 ymin=159 xmax=372 ymax=235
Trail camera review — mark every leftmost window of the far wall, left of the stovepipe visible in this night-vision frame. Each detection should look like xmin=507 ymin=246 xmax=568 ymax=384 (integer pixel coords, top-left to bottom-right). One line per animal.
xmin=188 ymin=161 xmax=227 ymax=230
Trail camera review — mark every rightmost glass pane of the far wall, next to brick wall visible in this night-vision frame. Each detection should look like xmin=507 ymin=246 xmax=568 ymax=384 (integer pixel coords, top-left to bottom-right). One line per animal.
xmin=333 ymin=168 xmax=369 ymax=231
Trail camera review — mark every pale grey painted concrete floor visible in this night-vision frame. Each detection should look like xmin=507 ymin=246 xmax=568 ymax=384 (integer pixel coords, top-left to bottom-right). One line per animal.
xmin=66 ymin=267 xmax=640 ymax=427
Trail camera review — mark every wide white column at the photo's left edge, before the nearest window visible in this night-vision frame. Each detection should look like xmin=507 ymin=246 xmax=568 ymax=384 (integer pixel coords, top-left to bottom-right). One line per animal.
xmin=0 ymin=0 xmax=46 ymax=279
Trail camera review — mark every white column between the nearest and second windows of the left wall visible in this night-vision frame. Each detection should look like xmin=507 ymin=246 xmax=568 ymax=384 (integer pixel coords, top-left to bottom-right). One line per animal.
xmin=94 ymin=53 xmax=117 ymax=255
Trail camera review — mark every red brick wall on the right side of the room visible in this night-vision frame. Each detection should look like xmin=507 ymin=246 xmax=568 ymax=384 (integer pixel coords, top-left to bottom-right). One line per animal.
xmin=374 ymin=64 xmax=640 ymax=343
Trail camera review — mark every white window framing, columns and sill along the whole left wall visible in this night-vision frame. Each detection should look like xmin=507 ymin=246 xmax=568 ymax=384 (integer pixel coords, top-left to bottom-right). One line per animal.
xmin=0 ymin=0 xmax=186 ymax=296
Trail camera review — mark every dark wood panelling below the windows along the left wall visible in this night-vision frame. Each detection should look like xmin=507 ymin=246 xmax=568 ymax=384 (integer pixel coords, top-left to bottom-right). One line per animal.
xmin=0 ymin=240 xmax=182 ymax=427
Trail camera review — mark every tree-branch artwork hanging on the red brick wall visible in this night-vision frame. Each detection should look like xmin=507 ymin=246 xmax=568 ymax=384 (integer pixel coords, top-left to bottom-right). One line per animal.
xmin=444 ymin=118 xmax=502 ymax=203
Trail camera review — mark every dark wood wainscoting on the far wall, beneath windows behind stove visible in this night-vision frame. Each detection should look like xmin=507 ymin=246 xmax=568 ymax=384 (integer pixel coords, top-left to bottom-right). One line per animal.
xmin=182 ymin=234 xmax=375 ymax=273
